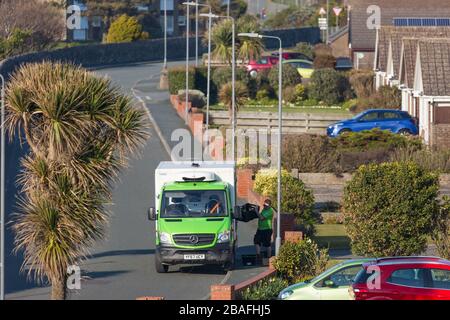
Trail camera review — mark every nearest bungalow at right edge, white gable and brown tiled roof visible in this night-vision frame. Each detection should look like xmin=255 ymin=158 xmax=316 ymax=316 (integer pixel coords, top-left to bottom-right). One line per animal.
xmin=413 ymin=38 xmax=450 ymax=148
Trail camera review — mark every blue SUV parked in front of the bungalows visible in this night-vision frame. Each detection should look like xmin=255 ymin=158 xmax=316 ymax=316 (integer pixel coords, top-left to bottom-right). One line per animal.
xmin=327 ymin=109 xmax=419 ymax=137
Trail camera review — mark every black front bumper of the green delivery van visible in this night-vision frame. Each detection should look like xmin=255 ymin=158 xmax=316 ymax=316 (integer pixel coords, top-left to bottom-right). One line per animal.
xmin=156 ymin=243 xmax=233 ymax=265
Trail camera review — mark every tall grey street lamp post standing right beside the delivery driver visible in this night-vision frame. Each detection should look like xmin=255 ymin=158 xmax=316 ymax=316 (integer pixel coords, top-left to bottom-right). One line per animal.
xmin=238 ymin=33 xmax=283 ymax=255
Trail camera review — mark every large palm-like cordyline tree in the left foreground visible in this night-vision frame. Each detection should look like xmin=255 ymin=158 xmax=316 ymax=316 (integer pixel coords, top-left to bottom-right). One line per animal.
xmin=5 ymin=62 xmax=148 ymax=299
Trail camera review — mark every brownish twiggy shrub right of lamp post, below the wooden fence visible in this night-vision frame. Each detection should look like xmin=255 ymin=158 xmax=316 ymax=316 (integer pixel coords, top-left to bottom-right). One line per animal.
xmin=282 ymin=135 xmax=338 ymax=173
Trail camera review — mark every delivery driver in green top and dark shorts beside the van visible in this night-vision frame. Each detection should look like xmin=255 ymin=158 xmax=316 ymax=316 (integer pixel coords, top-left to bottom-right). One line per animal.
xmin=253 ymin=199 xmax=273 ymax=261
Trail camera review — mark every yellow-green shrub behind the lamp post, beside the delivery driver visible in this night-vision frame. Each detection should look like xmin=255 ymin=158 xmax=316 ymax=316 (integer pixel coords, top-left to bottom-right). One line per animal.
xmin=255 ymin=170 xmax=315 ymax=235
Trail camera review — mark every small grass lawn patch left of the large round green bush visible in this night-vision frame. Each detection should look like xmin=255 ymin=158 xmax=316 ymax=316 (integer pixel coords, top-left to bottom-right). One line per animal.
xmin=313 ymin=224 xmax=350 ymax=249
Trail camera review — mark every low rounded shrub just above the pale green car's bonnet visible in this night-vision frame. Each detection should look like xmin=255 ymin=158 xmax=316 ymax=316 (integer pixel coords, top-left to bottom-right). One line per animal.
xmin=274 ymin=239 xmax=329 ymax=284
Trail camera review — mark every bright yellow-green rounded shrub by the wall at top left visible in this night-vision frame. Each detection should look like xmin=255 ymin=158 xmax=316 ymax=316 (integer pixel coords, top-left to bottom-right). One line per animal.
xmin=106 ymin=14 xmax=149 ymax=43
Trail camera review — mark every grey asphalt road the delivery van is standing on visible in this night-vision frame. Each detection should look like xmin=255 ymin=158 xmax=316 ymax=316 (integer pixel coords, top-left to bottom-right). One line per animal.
xmin=5 ymin=60 xmax=261 ymax=300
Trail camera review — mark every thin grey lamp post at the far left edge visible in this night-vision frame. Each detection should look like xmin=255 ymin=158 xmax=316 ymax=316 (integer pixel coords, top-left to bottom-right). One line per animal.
xmin=0 ymin=74 xmax=6 ymax=300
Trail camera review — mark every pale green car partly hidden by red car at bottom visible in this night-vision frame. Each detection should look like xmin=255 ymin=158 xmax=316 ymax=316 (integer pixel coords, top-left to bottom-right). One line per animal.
xmin=278 ymin=259 xmax=374 ymax=300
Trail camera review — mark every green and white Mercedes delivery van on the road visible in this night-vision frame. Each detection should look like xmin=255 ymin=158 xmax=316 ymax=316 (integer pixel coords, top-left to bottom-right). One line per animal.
xmin=149 ymin=162 xmax=241 ymax=273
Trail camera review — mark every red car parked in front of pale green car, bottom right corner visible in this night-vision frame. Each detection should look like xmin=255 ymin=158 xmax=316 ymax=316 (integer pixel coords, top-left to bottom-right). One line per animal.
xmin=349 ymin=257 xmax=450 ymax=300
